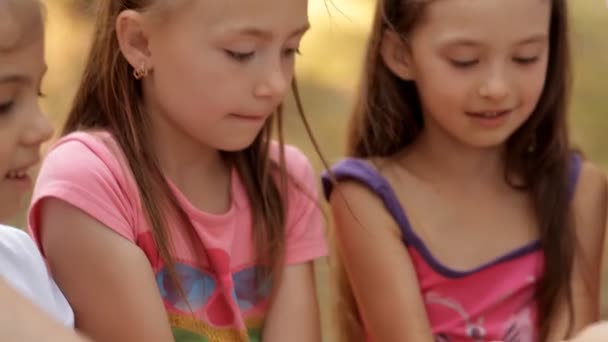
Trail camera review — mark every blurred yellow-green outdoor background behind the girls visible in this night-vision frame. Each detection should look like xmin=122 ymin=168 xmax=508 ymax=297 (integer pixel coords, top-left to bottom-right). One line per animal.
xmin=15 ymin=0 xmax=608 ymax=341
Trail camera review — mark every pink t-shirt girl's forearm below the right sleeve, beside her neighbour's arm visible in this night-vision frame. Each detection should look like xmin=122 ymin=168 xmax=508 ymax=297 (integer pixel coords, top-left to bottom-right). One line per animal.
xmin=263 ymin=262 xmax=321 ymax=342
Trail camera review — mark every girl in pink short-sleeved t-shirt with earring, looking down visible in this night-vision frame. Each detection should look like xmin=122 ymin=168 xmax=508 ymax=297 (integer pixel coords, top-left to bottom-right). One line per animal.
xmin=29 ymin=0 xmax=327 ymax=342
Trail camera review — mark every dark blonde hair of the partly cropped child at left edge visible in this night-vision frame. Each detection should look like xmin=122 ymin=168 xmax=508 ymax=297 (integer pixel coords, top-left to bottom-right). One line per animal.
xmin=0 ymin=0 xmax=44 ymax=53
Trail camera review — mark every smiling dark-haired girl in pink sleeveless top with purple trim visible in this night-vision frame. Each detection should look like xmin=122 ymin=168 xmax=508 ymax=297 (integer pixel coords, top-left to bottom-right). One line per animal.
xmin=325 ymin=0 xmax=606 ymax=342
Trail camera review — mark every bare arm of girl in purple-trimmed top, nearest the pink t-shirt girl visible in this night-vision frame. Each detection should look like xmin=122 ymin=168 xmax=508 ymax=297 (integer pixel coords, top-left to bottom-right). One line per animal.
xmin=331 ymin=182 xmax=433 ymax=342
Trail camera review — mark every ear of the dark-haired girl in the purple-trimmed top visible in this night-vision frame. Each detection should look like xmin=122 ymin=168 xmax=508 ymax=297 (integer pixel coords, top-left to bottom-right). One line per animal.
xmin=380 ymin=30 xmax=414 ymax=81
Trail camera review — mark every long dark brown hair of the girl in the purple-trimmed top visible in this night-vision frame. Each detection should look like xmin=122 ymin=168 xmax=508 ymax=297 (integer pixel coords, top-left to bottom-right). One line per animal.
xmin=338 ymin=0 xmax=576 ymax=341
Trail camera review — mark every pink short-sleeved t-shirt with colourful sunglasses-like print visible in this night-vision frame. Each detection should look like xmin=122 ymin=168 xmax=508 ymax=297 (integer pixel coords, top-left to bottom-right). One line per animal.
xmin=29 ymin=132 xmax=327 ymax=342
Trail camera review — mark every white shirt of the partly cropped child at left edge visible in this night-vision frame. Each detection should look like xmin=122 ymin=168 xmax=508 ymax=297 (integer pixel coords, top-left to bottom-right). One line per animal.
xmin=0 ymin=225 xmax=74 ymax=327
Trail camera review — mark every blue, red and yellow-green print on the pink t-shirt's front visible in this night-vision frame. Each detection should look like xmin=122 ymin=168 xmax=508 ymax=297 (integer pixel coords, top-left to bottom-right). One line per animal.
xmin=156 ymin=255 xmax=271 ymax=342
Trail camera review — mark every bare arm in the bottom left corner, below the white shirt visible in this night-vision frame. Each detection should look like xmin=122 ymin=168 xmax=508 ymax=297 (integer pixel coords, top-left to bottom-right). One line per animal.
xmin=0 ymin=280 xmax=90 ymax=342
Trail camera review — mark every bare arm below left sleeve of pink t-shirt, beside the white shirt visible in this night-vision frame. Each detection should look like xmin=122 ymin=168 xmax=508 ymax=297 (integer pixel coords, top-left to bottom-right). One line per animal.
xmin=41 ymin=199 xmax=173 ymax=342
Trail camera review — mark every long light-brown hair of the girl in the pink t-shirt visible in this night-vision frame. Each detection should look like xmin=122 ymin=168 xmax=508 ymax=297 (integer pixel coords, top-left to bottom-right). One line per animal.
xmin=63 ymin=0 xmax=303 ymax=299
